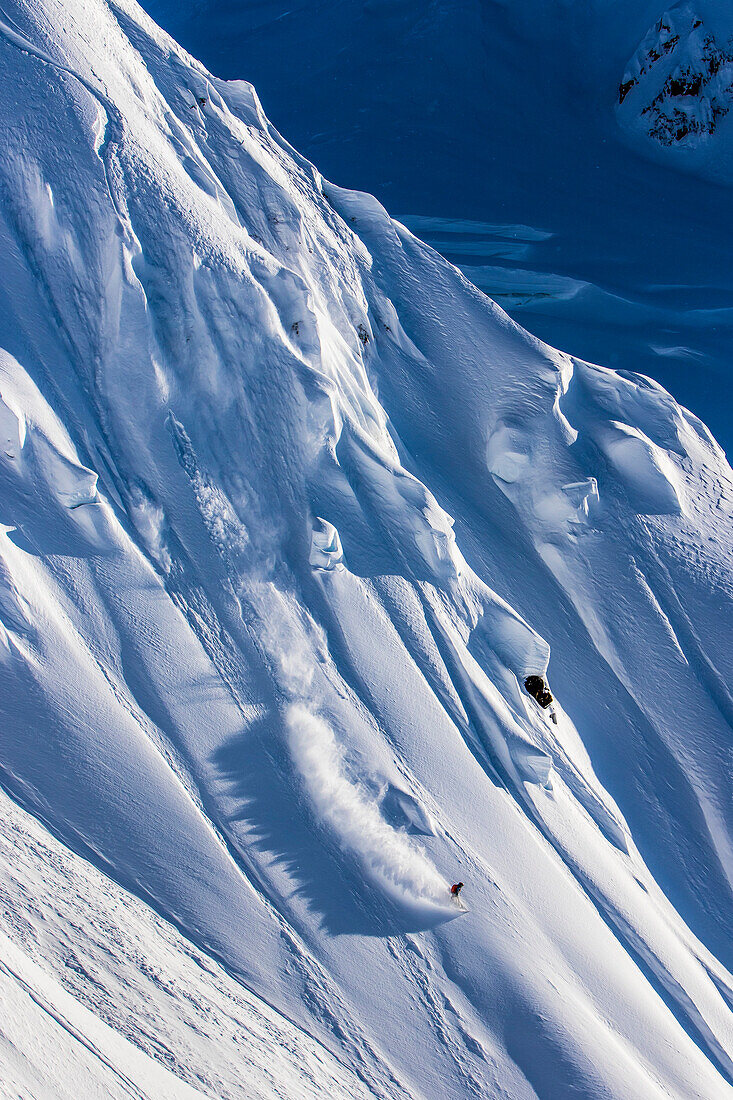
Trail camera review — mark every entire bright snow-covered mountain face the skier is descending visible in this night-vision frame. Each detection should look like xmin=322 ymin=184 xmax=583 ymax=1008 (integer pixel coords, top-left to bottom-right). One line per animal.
xmin=0 ymin=0 xmax=733 ymax=1100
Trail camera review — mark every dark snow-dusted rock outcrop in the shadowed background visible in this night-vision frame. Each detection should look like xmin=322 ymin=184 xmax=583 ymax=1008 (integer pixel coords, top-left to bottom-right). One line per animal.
xmin=617 ymin=3 xmax=733 ymax=145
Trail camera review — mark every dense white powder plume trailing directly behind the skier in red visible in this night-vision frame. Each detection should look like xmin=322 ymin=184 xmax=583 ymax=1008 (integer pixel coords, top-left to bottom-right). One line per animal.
xmin=286 ymin=703 xmax=449 ymax=905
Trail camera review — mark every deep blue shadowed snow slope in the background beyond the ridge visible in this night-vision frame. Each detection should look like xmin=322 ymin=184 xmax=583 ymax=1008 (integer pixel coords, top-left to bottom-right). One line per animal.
xmin=143 ymin=0 xmax=733 ymax=455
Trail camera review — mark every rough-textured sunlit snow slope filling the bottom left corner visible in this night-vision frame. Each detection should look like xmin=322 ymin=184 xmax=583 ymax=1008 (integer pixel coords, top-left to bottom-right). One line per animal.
xmin=0 ymin=793 xmax=369 ymax=1100
